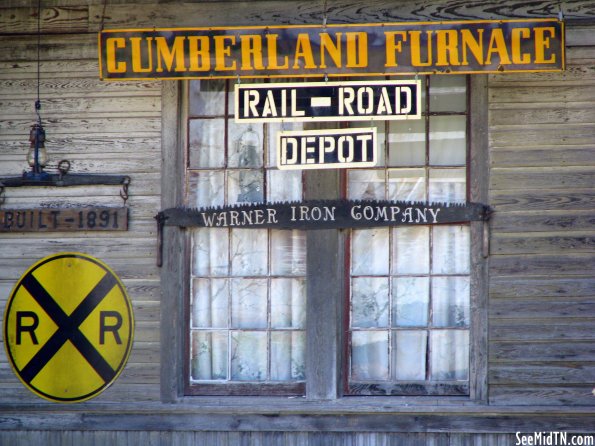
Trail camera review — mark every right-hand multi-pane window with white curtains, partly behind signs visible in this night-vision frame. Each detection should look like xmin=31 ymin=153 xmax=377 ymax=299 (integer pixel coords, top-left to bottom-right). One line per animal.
xmin=347 ymin=76 xmax=470 ymax=395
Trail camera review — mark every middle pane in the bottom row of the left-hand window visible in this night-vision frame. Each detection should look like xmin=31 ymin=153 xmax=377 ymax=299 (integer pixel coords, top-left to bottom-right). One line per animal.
xmin=231 ymin=331 xmax=267 ymax=381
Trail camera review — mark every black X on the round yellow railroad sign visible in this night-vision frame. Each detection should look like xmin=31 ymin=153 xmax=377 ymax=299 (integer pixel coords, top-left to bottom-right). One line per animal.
xmin=20 ymin=274 xmax=117 ymax=383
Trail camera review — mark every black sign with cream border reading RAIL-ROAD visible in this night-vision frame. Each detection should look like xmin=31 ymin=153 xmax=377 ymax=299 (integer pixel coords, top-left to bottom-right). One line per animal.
xmin=235 ymin=80 xmax=421 ymax=122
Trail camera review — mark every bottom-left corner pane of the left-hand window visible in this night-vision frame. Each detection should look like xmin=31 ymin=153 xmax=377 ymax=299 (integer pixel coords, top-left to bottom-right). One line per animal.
xmin=190 ymin=331 xmax=227 ymax=380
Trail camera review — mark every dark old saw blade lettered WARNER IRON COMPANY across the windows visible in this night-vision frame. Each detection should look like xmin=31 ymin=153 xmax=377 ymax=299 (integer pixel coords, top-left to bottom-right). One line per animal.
xmin=155 ymin=200 xmax=490 ymax=266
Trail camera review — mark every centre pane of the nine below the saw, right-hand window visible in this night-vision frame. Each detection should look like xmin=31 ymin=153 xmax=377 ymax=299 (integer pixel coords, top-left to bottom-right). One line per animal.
xmin=393 ymin=277 xmax=430 ymax=327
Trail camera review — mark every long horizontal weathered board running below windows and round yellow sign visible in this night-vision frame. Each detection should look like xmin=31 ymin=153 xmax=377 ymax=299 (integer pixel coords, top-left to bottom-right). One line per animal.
xmin=0 ymin=406 xmax=593 ymax=436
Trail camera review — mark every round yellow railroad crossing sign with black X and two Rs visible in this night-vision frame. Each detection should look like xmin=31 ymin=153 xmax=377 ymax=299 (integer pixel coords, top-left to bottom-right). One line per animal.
xmin=4 ymin=253 xmax=134 ymax=402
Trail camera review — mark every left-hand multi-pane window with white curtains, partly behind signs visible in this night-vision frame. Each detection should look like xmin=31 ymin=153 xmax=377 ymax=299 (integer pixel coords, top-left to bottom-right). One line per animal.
xmin=187 ymin=81 xmax=306 ymax=394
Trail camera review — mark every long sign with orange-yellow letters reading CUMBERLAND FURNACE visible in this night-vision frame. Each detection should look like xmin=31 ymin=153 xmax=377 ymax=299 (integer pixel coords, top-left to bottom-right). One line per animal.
xmin=98 ymin=19 xmax=564 ymax=80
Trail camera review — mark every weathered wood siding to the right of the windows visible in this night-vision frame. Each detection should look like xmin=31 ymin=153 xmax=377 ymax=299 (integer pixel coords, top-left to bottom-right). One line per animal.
xmin=489 ymin=27 xmax=595 ymax=405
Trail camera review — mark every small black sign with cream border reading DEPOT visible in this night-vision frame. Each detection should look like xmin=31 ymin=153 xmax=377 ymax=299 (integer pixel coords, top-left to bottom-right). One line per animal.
xmin=277 ymin=127 xmax=376 ymax=169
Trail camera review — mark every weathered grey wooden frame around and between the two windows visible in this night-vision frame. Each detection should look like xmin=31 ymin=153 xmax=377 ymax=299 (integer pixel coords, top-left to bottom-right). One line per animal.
xmin=160 ymin=75 xmax=489 ymax=405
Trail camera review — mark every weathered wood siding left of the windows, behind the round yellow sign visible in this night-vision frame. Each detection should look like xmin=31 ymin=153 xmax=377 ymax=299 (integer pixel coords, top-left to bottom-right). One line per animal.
xmin=0 ymin=33 xmax=161 ymax=403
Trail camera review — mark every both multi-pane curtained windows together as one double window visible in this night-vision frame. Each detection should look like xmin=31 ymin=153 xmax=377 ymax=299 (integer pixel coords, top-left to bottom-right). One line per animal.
xmin=184 ymin=76 xmax=486 ymax=395
